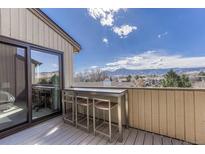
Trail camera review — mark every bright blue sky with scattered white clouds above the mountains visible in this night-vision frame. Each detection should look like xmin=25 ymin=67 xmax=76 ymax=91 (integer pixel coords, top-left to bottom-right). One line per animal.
xmin=42 ymin=9 xmax=205 ymax=72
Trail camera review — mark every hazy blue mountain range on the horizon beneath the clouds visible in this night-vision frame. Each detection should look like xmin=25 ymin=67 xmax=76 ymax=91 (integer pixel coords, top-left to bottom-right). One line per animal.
xmin=105 ymin=67 xmax=205 ymax=76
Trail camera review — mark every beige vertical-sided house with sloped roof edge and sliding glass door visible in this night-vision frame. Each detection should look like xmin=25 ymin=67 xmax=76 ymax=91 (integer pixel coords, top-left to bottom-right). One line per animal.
xmin=0 ymin=8 xmax=81 ymax=137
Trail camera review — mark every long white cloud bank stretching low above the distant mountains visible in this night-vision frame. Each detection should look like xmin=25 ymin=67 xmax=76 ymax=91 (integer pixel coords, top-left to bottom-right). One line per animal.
xmin=102 ymin=51 xmax=205 ymax=71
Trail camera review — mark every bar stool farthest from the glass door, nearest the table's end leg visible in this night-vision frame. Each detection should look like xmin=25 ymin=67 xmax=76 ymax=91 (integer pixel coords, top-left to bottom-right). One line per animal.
xmin=93 ymin=98 xmax=117 ymax=142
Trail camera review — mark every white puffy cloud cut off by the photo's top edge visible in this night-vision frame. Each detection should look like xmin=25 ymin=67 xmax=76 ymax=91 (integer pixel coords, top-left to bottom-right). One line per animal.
xmin=88 ymin=8 xmax=120 ymax=27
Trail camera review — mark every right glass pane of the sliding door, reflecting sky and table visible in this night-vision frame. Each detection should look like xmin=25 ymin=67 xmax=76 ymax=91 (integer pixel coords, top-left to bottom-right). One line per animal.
xmin=31 ymin=50 xmax=61 ymax=120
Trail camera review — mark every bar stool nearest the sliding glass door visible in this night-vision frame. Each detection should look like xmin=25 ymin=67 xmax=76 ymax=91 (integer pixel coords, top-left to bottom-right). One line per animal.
xmin=62 ymin=90 xmax=75 ymax=124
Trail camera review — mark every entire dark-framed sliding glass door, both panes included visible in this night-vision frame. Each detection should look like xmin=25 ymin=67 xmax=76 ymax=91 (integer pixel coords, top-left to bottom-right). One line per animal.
xmin=0 ymin=36 xmax=63 ymax=137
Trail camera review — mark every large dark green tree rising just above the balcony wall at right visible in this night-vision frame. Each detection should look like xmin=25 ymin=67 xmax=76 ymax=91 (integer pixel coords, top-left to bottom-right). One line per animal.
xmin=162 ymin=69 xmax=191 ymax=87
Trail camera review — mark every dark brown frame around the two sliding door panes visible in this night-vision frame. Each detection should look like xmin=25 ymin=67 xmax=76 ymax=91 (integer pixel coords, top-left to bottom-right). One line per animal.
xmin=0 ymin=35 xmax=64 ymax=139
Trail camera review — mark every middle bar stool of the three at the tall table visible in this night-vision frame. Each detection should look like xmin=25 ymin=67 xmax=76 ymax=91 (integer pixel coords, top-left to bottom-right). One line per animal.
xmin=75 ymin=96 xmax=92 ymax=132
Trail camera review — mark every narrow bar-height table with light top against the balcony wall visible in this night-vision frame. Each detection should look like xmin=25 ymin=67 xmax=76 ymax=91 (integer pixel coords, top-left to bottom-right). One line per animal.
xmin=64 ymin=88 xmax=129 ymax=142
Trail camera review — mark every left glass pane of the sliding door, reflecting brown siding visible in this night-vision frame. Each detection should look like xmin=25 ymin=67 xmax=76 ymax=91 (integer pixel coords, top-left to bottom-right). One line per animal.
xmin=0 ymin=43 xmax=28 ymax=132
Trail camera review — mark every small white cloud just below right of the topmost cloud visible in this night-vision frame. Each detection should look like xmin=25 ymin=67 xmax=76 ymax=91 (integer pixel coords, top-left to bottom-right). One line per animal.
xmin=113 ymin=25 xmax=137 ymax=38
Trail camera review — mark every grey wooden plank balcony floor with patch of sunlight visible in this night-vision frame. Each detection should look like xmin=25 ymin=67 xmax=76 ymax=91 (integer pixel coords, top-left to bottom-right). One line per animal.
xmin=0 ymin=116 xmax=189 ymax=145
